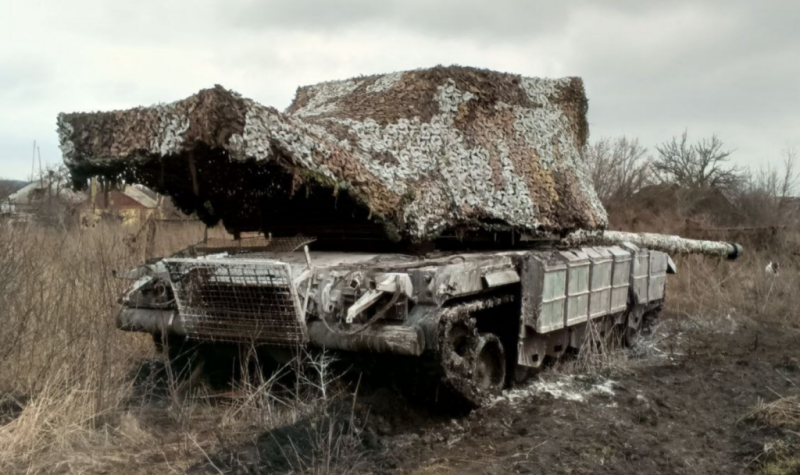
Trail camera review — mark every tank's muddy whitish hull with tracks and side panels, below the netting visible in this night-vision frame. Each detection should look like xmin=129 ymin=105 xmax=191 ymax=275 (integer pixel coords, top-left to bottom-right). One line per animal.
xmin=118 ymin=245 xmax=670 ymax=407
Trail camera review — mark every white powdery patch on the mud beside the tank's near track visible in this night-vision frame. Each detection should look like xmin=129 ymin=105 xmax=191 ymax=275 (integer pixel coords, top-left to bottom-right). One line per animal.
xmin=492 ymin=375 xmax=615 ymax=405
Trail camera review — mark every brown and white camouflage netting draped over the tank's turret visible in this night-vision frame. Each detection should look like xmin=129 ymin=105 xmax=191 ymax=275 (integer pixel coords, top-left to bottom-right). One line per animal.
xmin=58 ymin=67 xmax=606 ymax=242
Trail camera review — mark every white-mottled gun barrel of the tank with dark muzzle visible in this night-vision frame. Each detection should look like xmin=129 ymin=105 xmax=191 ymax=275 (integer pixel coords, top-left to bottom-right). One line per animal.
xmin=567 ymin=231 xmax=743 ymax=259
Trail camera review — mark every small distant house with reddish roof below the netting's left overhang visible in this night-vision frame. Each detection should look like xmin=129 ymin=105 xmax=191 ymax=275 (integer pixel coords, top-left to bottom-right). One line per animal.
xmin=81 ymin=185 xmax=163 ymax=227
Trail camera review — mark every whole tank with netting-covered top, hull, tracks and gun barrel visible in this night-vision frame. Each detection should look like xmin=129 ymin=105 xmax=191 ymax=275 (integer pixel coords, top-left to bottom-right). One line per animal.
xmin=58 ymin=67 xmax=742 ymax=406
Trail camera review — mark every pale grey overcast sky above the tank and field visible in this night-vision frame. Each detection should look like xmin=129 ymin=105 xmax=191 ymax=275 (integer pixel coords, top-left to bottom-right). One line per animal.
xmin=0 ymin=0 xmax=800 ymax=179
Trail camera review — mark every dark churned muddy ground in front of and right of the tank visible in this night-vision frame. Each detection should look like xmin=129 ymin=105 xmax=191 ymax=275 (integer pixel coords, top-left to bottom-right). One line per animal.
xmin=192 ymin=315 xmax=800 ymax=475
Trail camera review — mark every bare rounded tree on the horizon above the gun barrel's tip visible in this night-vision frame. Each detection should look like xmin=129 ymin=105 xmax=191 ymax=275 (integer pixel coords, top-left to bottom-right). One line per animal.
xmin=653 ymin=131 xmax=745 ymax=192
